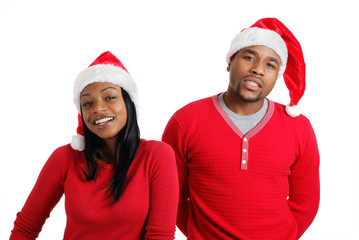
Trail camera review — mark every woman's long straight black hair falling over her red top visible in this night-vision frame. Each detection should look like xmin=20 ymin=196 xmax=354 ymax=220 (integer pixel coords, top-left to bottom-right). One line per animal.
xmin=82 ymin=88 xmax=140 ymax=204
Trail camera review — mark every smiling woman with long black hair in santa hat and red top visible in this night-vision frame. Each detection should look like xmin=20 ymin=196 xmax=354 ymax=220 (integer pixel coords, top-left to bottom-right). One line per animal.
xmin=10 ymin=52 xmax=178 ymax=240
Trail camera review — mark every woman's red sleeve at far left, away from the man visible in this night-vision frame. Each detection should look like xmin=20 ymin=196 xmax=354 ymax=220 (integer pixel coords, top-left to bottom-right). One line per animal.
xmin=10 ymin=148 xmax=65 ymax=240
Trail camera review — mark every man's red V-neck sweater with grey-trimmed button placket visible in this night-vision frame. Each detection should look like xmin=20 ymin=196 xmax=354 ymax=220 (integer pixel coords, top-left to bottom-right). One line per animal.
xmin=163 ymin=96 xmax=319 ymax=240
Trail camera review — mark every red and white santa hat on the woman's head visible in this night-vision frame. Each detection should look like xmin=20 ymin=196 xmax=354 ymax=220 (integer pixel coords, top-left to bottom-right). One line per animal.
xmin=71 ymin=52 xmax=139 ymax=151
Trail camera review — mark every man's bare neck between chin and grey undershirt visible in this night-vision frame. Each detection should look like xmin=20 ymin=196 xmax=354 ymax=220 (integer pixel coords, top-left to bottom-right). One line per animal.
xmin=223 ymin=91 xmax=264 ymax=115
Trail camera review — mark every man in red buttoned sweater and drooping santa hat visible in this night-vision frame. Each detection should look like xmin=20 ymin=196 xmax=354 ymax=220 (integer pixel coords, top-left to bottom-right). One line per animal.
xmin=163 ymin=18 xmax=319 ymax=240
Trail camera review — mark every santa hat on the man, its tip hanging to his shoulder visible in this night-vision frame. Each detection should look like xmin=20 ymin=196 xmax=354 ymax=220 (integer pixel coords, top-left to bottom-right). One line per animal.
xmin=226 ymin=18 xmax=305 ymax=117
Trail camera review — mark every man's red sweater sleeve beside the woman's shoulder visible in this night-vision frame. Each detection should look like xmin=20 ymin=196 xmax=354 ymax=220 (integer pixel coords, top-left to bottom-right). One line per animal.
xmin=162 ymin=113 xmax=189 ymax=236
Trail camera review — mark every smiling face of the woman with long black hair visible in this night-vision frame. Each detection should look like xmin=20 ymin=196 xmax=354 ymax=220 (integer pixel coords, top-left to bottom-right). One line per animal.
xmin=80 ymin=82 xmax=127 ymax=141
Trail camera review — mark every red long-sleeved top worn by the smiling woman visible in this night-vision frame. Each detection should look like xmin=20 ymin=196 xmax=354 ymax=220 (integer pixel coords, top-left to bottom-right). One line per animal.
xmin=10 ymin=140 xmax=178 ymax=240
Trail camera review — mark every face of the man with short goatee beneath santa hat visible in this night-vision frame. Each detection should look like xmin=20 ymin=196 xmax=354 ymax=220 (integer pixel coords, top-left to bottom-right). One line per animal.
xmin=227 ymin=46 xmax=281 ymax=102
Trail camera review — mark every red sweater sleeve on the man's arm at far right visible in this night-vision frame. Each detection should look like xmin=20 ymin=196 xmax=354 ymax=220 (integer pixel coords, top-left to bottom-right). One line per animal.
xmin=288 ymin=116 xmax=320 ymax=238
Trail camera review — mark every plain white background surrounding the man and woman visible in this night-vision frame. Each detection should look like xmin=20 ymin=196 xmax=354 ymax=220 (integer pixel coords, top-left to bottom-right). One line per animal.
xmin=0 ymin=0 xmax=359 ymax=240
